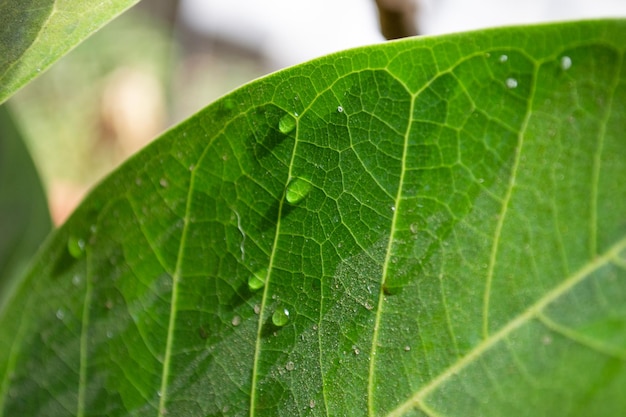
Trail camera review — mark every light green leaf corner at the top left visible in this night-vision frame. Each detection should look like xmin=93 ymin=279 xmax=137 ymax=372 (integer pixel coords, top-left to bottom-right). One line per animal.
xmin=0 ymin=0 xmax=139 ymax=104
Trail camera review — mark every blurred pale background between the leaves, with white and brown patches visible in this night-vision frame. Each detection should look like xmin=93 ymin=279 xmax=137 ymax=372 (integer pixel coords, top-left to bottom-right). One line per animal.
xmin=9 ymin=0 xmax=626 ymax=224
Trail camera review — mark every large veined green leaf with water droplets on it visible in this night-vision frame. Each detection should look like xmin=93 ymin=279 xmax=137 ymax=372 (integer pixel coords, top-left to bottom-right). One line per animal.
xmin=0 ymin=21 xmax=626 ymax=416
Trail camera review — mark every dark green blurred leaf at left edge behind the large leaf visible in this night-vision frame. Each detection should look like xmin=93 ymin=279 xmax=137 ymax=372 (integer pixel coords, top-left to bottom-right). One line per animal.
xmin=0 ymin=106 xmax=52 ymax=309
